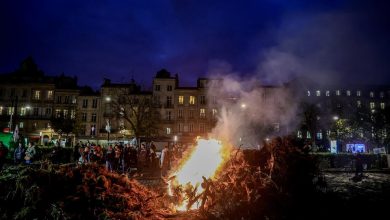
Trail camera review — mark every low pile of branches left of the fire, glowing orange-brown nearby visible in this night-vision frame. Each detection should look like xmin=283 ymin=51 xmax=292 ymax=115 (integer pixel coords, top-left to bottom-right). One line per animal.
xmin=0 ymin=164 xmax=170 ymax=219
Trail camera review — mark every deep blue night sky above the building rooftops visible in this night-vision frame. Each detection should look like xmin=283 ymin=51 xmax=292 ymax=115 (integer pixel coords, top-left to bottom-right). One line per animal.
xmin=0 ymin=0 xmax=390 ymax=88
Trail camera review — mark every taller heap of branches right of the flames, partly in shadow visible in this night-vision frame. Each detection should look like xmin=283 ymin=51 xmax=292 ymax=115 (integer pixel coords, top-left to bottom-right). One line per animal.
xmin=169 ymin=138 xmax=319 ymax=219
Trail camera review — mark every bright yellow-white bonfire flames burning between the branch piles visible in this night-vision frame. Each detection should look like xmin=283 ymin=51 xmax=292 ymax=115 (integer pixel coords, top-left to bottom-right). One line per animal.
xmin=168 ymin=139 xmax=229 ymax=211
